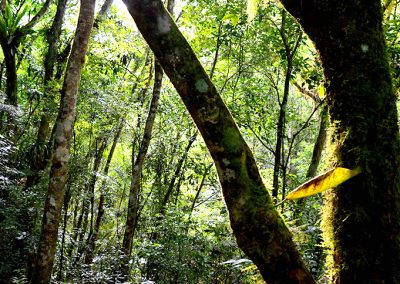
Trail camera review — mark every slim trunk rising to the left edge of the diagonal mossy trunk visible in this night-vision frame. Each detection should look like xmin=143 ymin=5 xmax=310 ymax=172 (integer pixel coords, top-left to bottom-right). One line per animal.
xmin=121 ymin=60 xmax=163 ymax=277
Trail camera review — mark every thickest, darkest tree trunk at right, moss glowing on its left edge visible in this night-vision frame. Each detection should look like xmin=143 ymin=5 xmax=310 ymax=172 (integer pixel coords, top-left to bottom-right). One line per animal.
xmin=282 ymin=0 xmax=400 ymax=283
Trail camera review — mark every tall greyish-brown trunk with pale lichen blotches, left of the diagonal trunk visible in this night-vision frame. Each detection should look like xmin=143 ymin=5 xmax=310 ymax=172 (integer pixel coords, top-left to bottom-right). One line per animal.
xmin=34 ymin=0 xmax=95 ymax=283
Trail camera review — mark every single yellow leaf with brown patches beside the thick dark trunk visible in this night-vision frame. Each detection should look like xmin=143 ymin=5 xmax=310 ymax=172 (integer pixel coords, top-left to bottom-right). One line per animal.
xmin=286 ymin=167 xmax=361 ymax=199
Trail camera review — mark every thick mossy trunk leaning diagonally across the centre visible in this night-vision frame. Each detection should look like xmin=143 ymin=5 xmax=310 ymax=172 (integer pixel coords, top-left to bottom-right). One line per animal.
xmin=125 ymin=0 xmax=314 ymax=283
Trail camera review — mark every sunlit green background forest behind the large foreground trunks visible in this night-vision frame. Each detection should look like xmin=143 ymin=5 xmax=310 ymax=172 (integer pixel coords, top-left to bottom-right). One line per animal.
xmin=0 ymin=0 xmax=399 ymax=283
